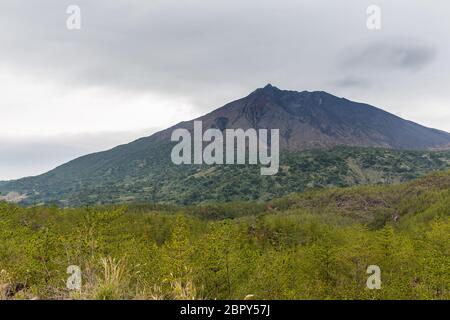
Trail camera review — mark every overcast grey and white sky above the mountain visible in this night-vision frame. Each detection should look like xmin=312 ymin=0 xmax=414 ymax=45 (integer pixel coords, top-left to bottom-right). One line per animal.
xmin=0 ymin=0 xmax=450 ymax=180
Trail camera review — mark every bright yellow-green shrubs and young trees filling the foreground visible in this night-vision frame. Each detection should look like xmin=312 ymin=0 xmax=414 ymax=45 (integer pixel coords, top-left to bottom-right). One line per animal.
xmin=0 ymin=170 xmax=450 ymax=299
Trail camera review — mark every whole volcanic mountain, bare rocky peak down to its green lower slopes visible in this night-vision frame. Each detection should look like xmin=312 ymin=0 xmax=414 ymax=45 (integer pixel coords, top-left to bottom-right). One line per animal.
xmin=0 ymin=85 xmax=450 ymax=205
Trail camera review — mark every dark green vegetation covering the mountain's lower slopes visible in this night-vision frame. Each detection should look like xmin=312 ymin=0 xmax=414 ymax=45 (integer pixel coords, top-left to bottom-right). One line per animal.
xmin=0 ymin=146 xmax=450 ymax=206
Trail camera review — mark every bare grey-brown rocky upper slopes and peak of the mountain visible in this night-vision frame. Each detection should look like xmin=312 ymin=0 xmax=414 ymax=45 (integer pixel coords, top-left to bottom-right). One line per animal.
xmin=158 ymin=84 xmax=450 ymax=151
